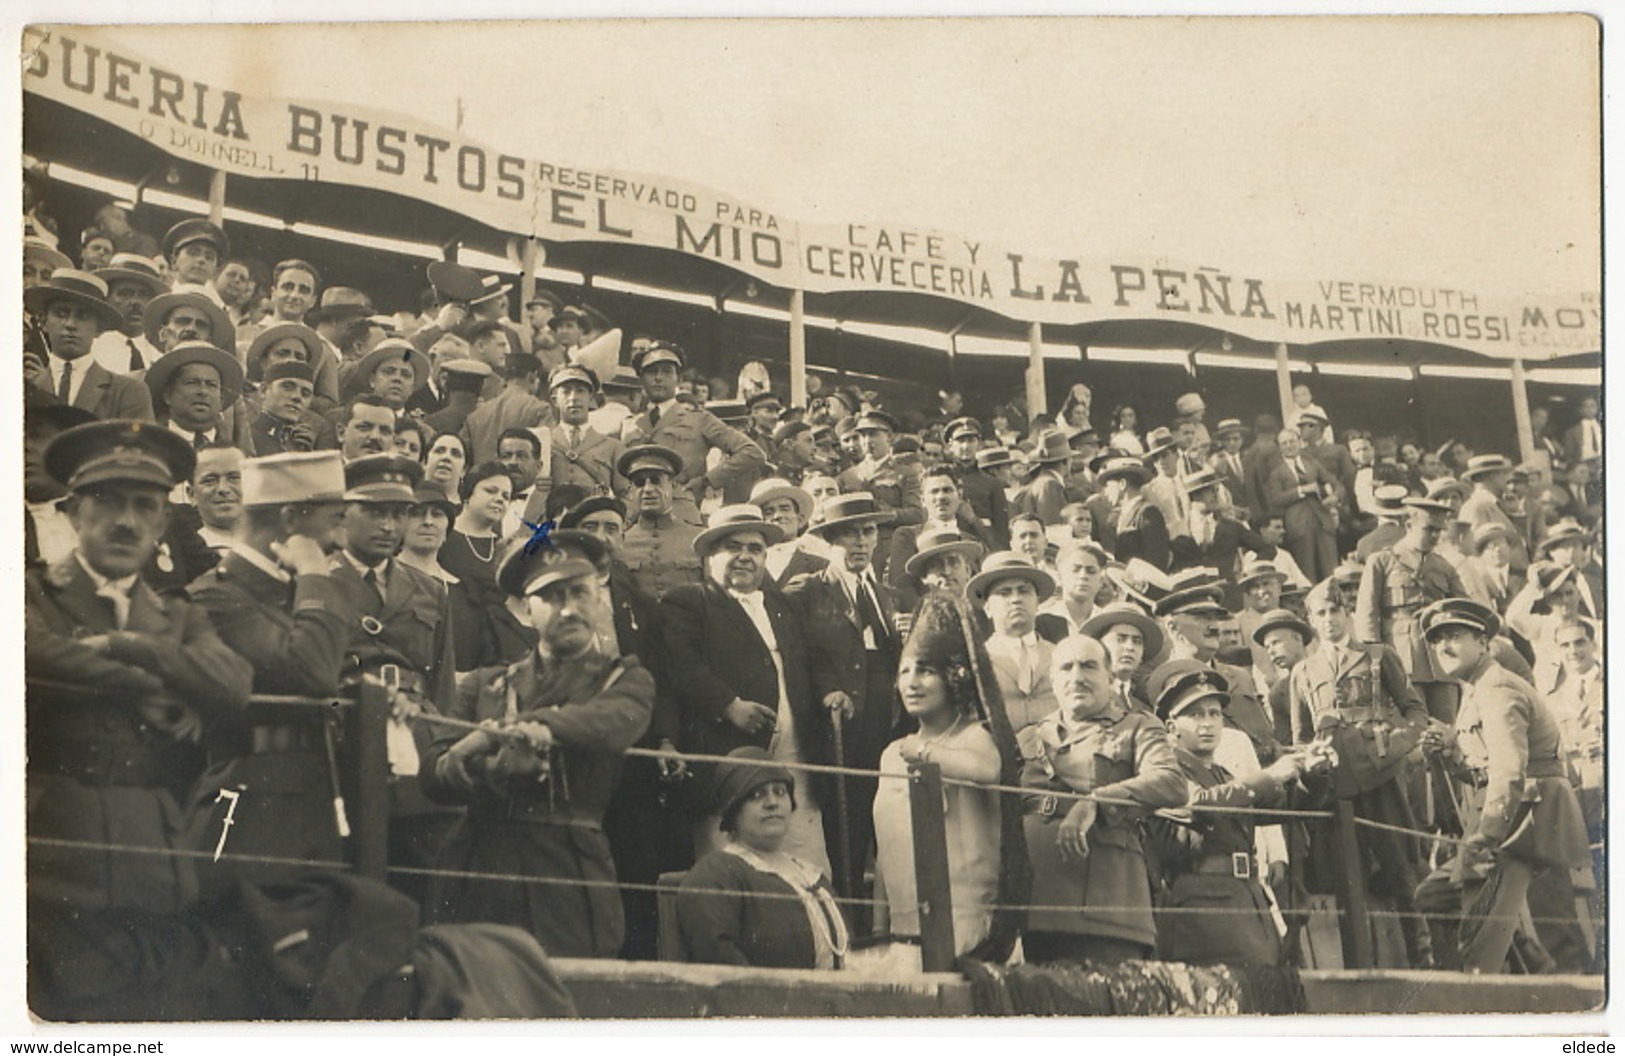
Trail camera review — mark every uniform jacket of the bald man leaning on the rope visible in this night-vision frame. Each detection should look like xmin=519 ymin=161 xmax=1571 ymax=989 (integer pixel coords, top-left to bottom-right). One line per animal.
xmin=1016 ymin=703 xmax=1186 ymax=947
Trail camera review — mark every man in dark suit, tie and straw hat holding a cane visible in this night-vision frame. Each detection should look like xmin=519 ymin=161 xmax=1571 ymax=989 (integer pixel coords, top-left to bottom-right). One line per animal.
xmin=785 ymin=491 xmax=902 ymax=897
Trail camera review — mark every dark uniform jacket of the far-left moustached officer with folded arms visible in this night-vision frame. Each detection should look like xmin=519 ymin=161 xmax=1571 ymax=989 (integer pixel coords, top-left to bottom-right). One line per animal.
xmin=23 ymin=554 xmax=252 ymax=913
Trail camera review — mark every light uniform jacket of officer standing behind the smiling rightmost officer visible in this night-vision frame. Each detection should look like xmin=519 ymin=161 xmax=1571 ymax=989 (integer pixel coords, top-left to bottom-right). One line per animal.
xmin=1354 ymin=539 xmax=1467 ymax=682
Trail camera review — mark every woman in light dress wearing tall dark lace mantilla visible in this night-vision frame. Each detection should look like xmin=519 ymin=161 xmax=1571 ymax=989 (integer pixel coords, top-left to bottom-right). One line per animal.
xmin=855 ymin=593 xmax=1030 ymax=973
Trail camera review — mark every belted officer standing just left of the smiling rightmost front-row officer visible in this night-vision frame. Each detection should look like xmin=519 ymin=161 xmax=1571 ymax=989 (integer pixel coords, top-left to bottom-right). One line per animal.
xmin=1289 ymin=580 xmax=1433 ymax=968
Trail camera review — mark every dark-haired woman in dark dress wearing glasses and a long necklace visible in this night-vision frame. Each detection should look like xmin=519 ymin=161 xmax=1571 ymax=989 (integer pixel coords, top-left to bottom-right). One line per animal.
xmin=431 ymin=458 xmax=536 ymax=671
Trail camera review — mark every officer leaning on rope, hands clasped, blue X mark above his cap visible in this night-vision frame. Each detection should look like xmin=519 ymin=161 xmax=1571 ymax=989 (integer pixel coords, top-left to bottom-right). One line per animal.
xmin=423 ymin=533 xmax=655 ymax=957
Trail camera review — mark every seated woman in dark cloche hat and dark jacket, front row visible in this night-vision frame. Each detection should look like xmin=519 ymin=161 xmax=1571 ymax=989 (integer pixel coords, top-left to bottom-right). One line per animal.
xmin=678 ymin=747 xmax=847 ymax=968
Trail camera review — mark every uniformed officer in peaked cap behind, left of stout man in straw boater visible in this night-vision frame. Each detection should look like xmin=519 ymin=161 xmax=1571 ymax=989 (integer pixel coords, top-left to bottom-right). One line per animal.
xmin=616 ymin=444 xmax=702 ymax=599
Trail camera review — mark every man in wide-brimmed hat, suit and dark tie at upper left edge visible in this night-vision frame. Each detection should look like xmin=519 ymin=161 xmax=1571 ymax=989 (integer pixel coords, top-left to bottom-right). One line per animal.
xmin=23 ymin=268 xmax=153 ymax=422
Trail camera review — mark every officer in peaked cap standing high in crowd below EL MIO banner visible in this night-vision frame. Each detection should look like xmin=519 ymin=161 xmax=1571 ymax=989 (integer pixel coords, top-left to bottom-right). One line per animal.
xmin=621 ymin=341 xmax=767 ymax=525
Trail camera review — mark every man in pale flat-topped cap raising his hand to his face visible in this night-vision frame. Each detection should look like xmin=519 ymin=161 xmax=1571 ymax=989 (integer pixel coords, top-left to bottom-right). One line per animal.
xmin=189 ymin=452 xmax=361 ymax=879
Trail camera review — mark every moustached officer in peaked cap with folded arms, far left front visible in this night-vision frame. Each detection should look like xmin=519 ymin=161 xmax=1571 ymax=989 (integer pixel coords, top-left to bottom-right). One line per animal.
xmin=23 ymin=421 xmax=249 ymax=922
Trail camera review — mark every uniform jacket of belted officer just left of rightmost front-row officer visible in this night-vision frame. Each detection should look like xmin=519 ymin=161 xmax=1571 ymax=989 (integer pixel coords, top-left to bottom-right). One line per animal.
xmin=1287 ymin=642 xmax=1427 ymax=798
